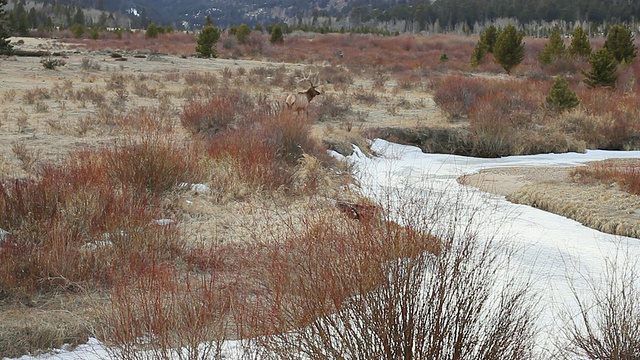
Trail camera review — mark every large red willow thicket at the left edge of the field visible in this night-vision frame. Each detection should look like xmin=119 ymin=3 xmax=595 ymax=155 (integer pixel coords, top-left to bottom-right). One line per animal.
xmin=0 ymin=137 xmax=200 ymax=295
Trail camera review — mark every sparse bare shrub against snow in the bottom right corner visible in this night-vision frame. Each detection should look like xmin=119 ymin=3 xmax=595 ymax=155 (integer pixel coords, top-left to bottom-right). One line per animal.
xmin=558 ymin=248 xmax=640 ymax=360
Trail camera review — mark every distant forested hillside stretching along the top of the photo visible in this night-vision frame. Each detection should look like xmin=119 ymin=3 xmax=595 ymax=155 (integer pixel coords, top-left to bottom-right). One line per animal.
xmin=2 ymin=0 xmax=640 ymax=32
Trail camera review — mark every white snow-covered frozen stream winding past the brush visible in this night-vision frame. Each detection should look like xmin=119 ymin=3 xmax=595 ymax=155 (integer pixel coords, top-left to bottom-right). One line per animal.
xmin=8 ymin=140 xmax=640 ymax=360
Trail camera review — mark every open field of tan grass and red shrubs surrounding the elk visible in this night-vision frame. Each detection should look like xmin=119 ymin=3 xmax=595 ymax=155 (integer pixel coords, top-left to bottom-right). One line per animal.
xmin=0 ymin=34 xmax=640 ymax=356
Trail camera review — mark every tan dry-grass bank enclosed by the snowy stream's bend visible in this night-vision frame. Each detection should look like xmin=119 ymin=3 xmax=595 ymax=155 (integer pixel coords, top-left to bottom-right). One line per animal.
xmin=459 ymin=167 xmax=640 ymax=238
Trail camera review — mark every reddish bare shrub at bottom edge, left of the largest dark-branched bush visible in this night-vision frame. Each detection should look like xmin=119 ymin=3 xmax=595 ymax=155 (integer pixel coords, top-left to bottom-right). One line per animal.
xmin=99 ymin=263 xmax=230 ymax=360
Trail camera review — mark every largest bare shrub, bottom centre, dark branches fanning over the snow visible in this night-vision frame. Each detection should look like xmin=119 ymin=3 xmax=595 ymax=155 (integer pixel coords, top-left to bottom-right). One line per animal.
xmin=248 ymin=187 xmax=536 ymax=360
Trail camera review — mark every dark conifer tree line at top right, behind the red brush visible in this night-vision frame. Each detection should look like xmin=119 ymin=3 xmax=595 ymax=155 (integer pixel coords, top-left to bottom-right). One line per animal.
xmin=302 ymin=0 xmax=640 ymax=30
